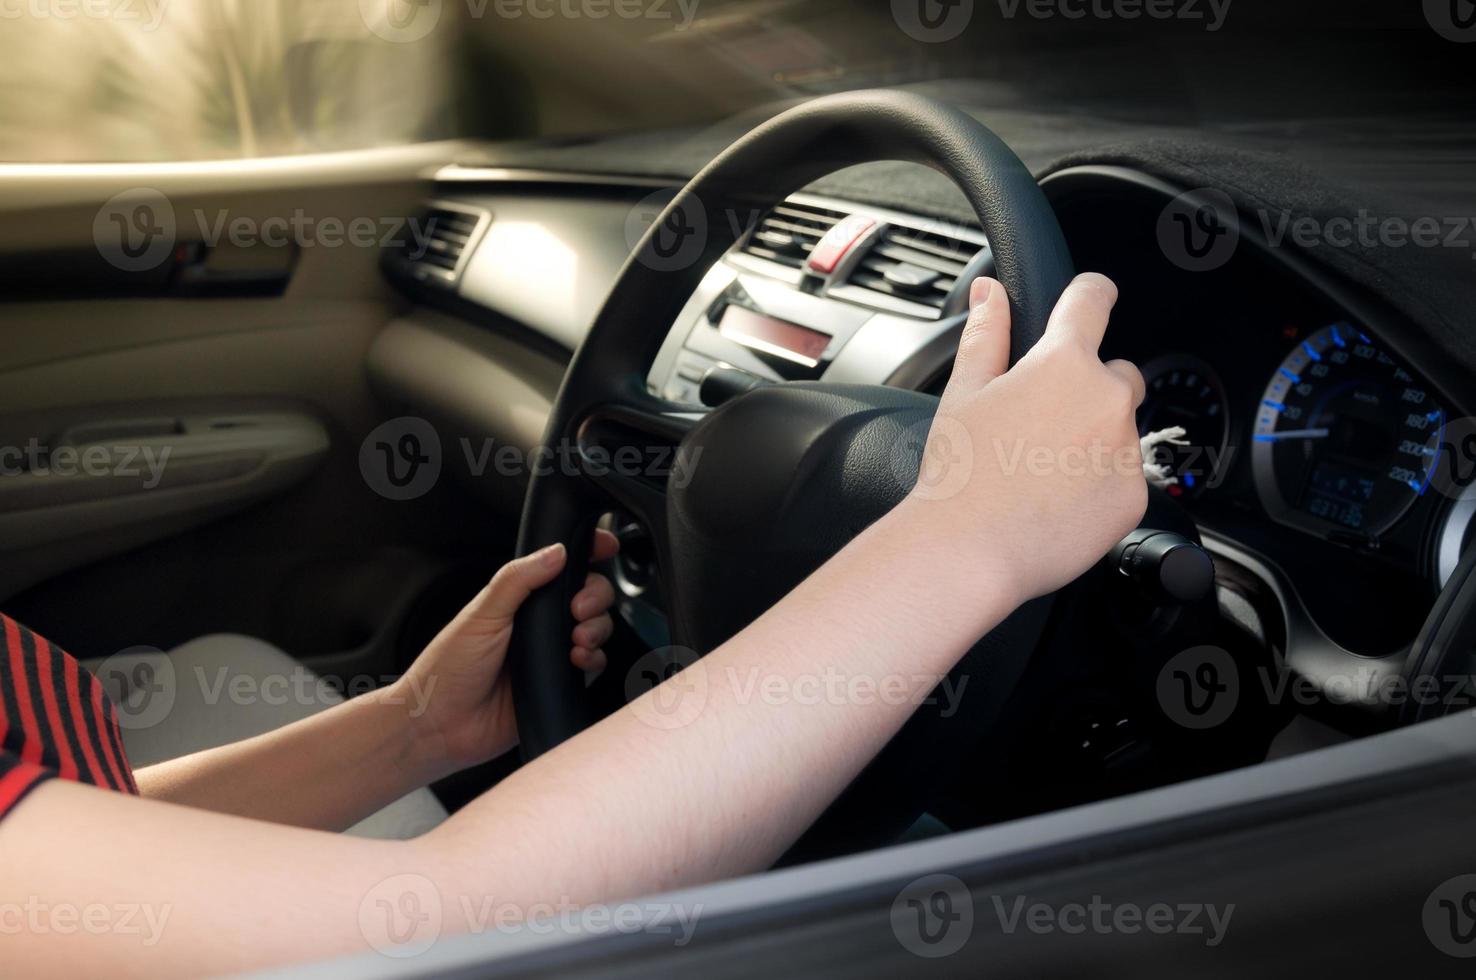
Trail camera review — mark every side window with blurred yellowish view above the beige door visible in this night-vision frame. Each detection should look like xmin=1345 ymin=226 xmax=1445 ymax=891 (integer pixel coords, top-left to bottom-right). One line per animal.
xmin=0 ymin=0 xmax=455 ymax=162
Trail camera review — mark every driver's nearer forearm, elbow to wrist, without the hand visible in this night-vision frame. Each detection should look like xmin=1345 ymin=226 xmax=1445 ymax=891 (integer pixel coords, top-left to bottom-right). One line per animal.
xmin=419 ymin=502 xmax=1015 ymax=903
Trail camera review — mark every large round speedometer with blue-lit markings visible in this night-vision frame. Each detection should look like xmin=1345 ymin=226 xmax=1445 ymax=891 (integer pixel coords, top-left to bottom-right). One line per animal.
xmin=1252 ymin=323 xmax=1445 ymax=540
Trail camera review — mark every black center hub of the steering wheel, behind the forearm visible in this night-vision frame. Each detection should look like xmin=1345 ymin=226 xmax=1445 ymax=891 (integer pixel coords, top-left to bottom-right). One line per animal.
xmin=667 ymin=382 xmax=937 ymax=652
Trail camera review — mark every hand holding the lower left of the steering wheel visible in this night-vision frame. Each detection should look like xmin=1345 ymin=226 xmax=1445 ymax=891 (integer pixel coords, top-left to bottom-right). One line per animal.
xmin=394 ymin=531 xmax=620 ymax=775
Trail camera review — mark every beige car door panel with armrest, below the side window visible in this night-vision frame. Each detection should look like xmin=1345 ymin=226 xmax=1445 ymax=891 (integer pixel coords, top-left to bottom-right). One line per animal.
xmin=0 ymin=145 xmax=515 ymax=670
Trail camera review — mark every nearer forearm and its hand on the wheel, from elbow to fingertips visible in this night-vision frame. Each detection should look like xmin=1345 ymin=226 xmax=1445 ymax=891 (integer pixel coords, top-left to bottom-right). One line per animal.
xmin=422 ymin=276 xmax=1147 ymax=900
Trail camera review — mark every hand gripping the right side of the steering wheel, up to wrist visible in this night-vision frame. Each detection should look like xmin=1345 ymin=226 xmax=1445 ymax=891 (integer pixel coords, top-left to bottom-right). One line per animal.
xmin=903 ymin=273 xmax=1148 ymax=602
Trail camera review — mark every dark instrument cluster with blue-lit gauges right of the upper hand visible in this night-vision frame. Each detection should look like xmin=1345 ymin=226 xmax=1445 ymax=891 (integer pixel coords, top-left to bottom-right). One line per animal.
xmin=1057 ymin=185 xmax=1476 ymax=657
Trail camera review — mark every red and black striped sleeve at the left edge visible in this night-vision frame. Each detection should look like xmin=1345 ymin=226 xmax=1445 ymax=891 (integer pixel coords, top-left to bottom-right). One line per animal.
xmin=0 ymin=614 xmax=139 ymax=819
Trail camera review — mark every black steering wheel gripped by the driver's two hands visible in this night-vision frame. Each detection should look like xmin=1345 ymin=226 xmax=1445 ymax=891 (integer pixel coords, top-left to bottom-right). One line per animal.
xmin=509 ymin=90 xmax=1073 ymax=850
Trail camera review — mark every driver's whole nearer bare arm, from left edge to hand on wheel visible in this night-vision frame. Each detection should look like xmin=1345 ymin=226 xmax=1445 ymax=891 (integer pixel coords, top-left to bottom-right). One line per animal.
xmin=0 ymin=277 xmax=1145 ymax=977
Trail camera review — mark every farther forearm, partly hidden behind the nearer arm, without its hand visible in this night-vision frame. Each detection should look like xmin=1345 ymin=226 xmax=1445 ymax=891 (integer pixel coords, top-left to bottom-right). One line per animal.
xmin=136 ymin=688 xmax=446 ymax=831
